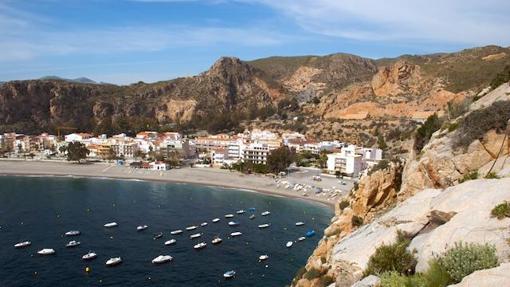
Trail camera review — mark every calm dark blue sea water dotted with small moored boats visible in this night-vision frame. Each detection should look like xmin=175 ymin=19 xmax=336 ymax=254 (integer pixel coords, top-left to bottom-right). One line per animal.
xmin=0 ymin=176 xmax=332 ymax=287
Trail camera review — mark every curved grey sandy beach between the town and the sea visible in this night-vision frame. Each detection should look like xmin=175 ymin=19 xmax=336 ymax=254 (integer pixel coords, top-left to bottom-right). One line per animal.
xmin=0 ymin=160 xmax=337 ymax=208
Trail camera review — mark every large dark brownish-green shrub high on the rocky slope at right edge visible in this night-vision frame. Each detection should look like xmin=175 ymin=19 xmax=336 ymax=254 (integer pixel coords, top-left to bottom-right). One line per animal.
xmin=454 ymin=101 xmax=510 ymax=148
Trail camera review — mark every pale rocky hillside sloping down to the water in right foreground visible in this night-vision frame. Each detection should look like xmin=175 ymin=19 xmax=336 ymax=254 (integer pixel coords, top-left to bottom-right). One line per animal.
xmin=292 ymin=83 xmax=510 ymax=287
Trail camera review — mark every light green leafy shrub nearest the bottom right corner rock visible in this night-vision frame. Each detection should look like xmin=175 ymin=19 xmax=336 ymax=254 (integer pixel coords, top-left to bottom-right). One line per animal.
xmin=437 ymin=242 xmax=498 ymax=283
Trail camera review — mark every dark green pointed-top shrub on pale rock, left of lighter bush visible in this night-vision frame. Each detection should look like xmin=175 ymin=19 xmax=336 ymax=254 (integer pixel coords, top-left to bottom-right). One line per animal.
xmin=365 ymin=231 xmax=417 ymax=276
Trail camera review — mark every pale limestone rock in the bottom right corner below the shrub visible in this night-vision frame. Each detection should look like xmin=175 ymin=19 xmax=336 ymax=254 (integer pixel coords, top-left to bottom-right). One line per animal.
xmin=448 ymin=263 xmax=510 ymax=287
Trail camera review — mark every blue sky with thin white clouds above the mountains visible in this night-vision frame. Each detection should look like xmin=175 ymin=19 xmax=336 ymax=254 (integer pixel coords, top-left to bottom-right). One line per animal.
xmin=0 ymin=0 xmax=510 ymax=84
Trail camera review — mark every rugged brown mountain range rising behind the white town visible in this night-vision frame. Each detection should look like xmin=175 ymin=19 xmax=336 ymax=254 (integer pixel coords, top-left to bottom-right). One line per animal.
xmin=0 ymin=46 xmax=510 ymax=142
